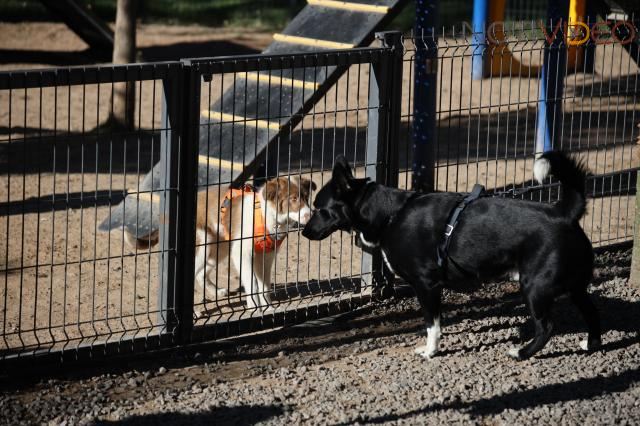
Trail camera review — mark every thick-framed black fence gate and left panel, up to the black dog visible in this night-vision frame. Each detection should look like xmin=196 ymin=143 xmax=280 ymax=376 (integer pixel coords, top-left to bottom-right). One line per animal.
xmin=0 ymin=40 xmax=402 ymax=365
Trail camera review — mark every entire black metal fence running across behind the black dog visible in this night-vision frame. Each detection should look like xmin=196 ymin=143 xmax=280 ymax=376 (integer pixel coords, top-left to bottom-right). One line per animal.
xmin=0 ymin=27 xmax=640 ymax=362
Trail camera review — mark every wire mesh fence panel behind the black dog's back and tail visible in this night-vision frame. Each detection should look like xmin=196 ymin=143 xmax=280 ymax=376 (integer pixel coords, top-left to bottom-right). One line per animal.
xmin=400 ymin=21 xmax=640 ymax=246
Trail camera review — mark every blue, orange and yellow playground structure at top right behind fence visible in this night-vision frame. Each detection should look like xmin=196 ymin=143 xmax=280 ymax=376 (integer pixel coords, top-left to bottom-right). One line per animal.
xmin=472 ymin=0 xmax=638 ymax=153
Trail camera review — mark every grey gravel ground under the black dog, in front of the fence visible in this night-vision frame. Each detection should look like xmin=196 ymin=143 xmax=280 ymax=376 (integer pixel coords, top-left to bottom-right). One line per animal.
xmin=0 ymin=251 xmax=640 ymax=425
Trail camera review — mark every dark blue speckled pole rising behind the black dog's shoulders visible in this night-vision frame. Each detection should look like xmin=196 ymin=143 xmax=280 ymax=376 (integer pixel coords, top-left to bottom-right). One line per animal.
xmin=412 ymin=0 xmax=438 ymax=192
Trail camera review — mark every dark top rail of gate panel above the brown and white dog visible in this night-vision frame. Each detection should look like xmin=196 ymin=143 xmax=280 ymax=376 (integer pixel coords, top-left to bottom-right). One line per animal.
xmin=183 ymin=47 xmax=390 ymax=74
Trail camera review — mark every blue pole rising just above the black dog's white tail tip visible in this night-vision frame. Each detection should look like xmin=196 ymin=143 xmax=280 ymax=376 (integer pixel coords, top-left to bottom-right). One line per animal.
xmin=536 ymin=0 xmax=569 ymax=153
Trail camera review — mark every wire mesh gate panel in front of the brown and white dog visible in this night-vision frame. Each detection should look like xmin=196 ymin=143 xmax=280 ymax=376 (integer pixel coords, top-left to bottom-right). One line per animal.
xmin=185 ymin=49 xmax=390 ymax=336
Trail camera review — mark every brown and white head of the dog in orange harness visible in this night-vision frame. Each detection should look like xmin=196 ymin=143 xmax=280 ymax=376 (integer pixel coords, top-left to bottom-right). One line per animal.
xmin=264 ymin=176 xmax=316 ymax=225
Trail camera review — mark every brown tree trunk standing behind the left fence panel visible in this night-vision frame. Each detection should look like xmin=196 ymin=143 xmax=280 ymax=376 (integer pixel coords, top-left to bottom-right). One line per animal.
xmin=111 ymin=0 xmax=137 ymax=129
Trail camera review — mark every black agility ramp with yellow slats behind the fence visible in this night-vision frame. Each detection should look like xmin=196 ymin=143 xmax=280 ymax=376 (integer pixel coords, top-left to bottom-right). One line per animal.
xmin=100 ymin=0 xmax=407 ymax=237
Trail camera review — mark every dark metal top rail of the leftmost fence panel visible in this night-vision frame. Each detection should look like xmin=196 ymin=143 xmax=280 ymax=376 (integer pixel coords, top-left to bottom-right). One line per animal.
xmin=0 ymin=61 xmax=181 ymax=90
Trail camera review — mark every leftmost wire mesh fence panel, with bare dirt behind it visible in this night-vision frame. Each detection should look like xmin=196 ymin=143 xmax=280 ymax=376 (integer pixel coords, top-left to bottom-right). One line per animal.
xmin=0 ymin=64 xmax=180 ymax=362
